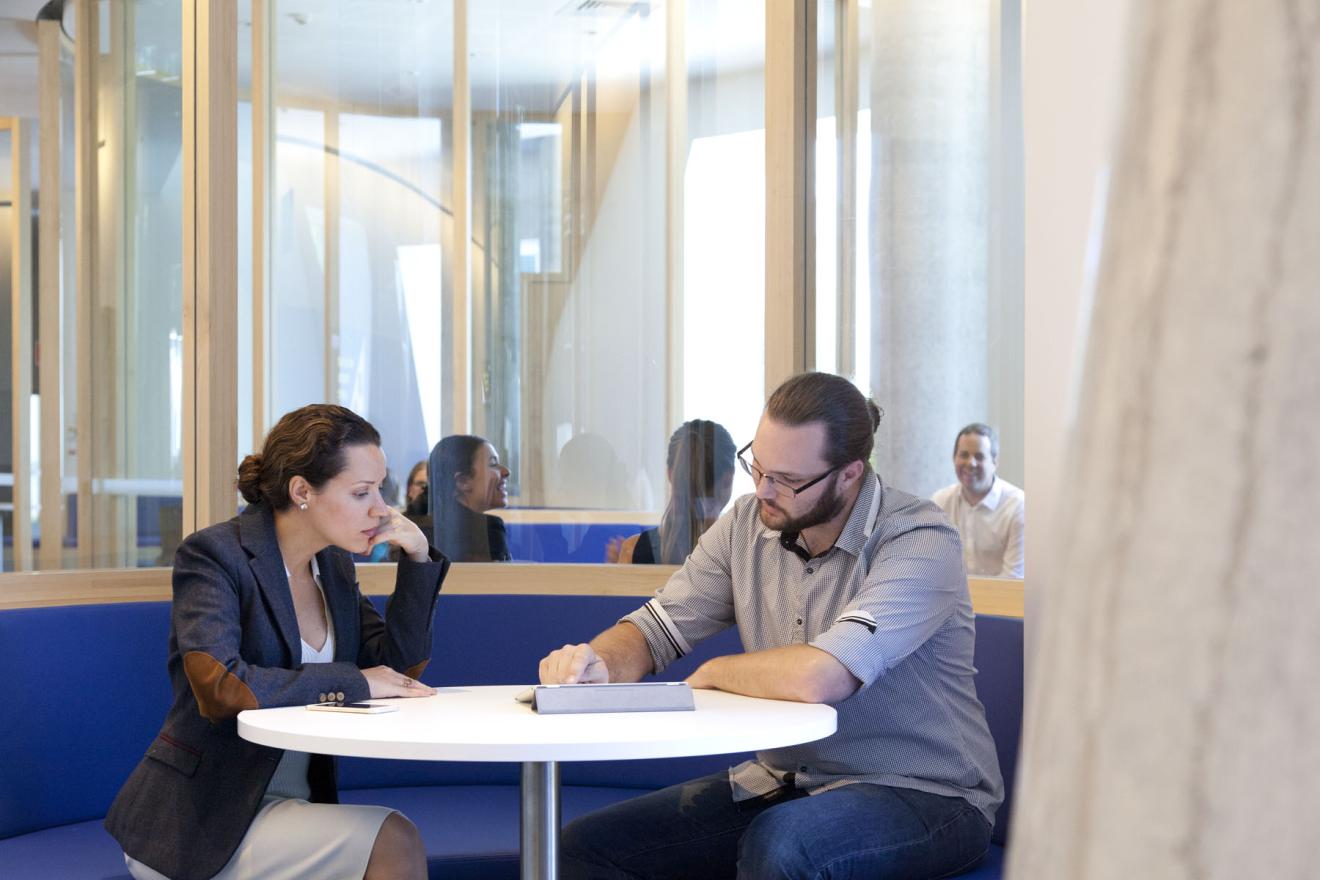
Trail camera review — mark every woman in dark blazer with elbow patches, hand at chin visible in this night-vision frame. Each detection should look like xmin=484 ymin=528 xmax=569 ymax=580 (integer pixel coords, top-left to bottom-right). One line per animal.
xmin=106 ymin=404 xmax=449 ymax=880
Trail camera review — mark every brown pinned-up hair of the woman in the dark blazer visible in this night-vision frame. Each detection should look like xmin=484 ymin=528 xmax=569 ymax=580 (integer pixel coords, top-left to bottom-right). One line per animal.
xmin=238 ymin=404 xmax=380 ymax=511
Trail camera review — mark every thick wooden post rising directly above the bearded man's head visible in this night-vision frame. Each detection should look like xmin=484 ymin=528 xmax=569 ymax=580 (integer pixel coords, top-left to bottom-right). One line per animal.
xmin=766 ymin=0 xmax=816 ymax=394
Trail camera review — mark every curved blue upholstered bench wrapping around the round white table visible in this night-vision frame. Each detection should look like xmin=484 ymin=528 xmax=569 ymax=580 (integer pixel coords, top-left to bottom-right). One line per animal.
xmin=0 ymin=595 xmax=1022 ymax=880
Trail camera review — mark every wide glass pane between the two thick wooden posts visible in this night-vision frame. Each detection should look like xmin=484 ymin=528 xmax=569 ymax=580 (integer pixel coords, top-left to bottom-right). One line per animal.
xmin=239 ymin=0 xmax=764 ymax=562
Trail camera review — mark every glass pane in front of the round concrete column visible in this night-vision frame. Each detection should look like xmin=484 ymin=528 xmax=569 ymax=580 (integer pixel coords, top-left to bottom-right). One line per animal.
xmin=814 ymin=0 xmax=1024 ymax=496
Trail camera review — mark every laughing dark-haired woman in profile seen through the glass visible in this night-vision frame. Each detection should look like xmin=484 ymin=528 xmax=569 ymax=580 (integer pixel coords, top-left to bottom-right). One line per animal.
xmin=428 ymin=434 xmax=510 ymax=562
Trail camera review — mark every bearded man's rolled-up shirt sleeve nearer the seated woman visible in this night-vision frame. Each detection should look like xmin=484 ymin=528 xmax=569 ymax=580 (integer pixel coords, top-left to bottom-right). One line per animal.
xmin=620 ymin=512 xmax=734 ymax=673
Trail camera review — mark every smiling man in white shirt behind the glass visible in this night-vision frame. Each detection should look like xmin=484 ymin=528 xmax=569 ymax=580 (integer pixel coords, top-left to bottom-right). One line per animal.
xmin=931 ymin=422 xmax=1027 ymax=578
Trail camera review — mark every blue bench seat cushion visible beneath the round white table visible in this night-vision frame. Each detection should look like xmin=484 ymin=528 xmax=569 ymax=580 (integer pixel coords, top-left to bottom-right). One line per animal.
xmin=339 ymin=785 xmax=647 ymax=880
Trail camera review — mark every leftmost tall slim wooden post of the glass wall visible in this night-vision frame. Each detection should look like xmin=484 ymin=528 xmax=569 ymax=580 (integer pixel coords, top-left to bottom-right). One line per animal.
xmin=37 ymin=20 xmax=65 ymax=569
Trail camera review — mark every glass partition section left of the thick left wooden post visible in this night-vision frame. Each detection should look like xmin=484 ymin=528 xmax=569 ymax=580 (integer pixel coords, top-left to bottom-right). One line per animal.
xmin=4 ymin=0 xmax=185 ymax=570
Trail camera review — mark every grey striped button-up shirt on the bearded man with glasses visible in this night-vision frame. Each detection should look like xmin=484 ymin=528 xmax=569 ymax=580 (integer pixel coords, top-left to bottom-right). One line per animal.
xmin=624 ymin=474 xmax=1003 ymax=822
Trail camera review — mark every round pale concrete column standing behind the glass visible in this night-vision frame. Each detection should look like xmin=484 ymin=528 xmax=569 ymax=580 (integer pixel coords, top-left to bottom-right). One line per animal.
xmin=870 ymin=0 xmax=991 ymax=495
